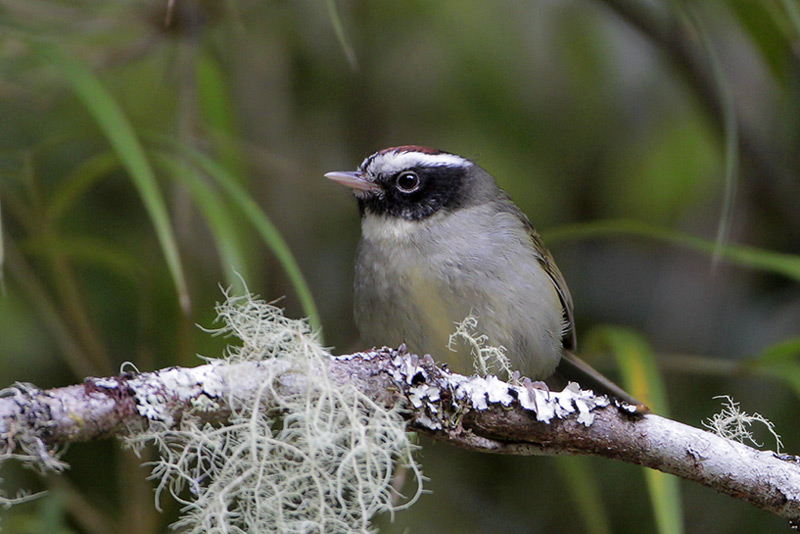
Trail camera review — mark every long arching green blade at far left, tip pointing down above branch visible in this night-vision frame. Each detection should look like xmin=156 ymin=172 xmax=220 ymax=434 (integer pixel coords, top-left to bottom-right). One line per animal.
xmin=33 ymin=43 xmax=190 ymax=311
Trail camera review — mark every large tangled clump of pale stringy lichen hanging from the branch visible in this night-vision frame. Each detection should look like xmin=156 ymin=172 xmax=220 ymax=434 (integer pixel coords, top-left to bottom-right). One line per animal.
xmin=132 ymin=295 xmax=422 ymax=534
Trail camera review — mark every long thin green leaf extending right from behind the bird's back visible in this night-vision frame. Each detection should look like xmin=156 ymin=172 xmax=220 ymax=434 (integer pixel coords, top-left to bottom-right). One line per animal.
xmin=543 ymin=220 xmax=800 ymax=281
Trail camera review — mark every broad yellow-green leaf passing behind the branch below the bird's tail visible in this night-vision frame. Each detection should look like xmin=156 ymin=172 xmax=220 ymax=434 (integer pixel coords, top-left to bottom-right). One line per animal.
xmin=586 ymin=326 xmax=683 ymax=534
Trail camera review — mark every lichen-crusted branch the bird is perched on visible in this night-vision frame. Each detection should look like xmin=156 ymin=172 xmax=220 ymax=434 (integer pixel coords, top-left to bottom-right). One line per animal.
xmin=0 ymin=349 xmax=800 ymax=526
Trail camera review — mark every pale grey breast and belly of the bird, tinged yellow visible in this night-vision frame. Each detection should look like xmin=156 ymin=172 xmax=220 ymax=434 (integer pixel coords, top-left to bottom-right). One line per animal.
xmin=355 ymin=209 xmax=563 ymax=379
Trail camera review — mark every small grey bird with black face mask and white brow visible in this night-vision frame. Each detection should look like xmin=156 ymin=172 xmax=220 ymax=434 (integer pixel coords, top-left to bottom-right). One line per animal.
xmin=325 ymin=145 xmax=640 ymax=405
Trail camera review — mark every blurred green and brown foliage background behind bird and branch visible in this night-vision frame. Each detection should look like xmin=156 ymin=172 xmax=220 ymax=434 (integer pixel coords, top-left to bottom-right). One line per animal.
xmin=0 ymin=0 xmax=800 ymax=534
